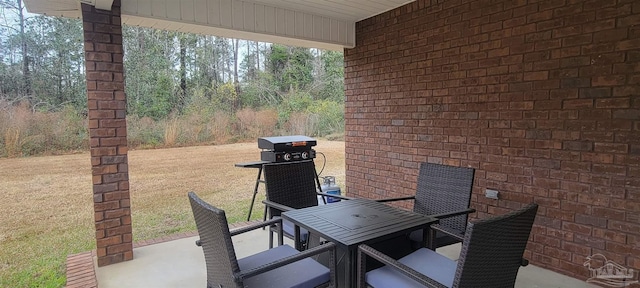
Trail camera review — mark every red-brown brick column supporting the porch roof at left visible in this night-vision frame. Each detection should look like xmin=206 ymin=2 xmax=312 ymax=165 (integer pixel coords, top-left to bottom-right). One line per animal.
xmin=82 ymin=0 xmax=133 ymax=266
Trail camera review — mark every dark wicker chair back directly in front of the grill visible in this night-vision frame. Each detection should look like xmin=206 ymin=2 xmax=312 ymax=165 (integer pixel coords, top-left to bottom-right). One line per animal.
xmin=263 ymin=160 xmax=318 ymax=217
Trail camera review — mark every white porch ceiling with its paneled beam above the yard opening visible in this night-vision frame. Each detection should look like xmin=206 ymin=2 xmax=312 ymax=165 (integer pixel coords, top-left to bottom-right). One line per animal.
xmin=23 ymin=0 xmax=414 ymax=50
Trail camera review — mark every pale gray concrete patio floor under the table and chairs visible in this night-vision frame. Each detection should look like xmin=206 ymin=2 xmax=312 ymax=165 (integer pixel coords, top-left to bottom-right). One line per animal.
xmin=96 ymin=229 xmax=597 ymax=288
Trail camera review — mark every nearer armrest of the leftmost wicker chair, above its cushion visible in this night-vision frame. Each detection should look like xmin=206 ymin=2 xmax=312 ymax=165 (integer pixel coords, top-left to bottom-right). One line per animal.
xmin=234 ymin=242 xmax=336 ymax=287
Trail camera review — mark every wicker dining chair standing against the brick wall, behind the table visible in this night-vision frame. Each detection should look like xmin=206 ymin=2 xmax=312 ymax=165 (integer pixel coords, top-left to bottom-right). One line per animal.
xmin=378 ymin=163 xmax=475 ymax=249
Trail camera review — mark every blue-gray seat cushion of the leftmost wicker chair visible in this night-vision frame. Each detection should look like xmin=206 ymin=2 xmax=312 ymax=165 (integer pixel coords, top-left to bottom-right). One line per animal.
xmin=238 ymin=245 xmax=330 ymax=288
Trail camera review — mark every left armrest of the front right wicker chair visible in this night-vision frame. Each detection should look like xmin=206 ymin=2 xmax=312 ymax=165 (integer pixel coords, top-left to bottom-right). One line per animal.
xmin=358 ymin=244 xmax=447 ymax=288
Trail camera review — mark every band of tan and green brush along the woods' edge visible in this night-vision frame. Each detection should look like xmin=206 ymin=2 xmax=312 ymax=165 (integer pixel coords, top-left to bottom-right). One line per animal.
xmin=0 ymin=91 xmax=344 ymax=157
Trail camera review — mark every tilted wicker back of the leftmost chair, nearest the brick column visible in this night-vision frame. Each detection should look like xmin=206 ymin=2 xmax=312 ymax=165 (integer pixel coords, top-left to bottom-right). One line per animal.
xmin=189 ymin=192 xmax=242 ymax=287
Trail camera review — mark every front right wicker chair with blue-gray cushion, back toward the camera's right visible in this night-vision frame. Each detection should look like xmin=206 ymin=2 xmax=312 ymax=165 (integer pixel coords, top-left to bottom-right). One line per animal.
xmin=358 ymin=204 xmax=538 ymax=288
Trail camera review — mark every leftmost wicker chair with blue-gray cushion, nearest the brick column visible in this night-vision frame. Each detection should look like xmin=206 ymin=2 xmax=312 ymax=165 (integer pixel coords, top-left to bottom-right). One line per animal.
xmin=189 ymin=192 xmax=336 ymax=288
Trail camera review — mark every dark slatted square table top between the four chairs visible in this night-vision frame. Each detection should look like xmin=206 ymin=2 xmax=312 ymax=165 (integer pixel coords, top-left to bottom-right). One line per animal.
xmin=282 ymin=199 xmax=438 ymax=247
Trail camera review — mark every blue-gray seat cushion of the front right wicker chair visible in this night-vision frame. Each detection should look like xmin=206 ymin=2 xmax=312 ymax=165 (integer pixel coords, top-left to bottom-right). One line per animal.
xmin=365 ymin=248 xmax=457 ymax=288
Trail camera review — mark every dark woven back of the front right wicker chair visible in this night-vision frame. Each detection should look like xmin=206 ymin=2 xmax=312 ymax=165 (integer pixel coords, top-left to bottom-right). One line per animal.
xmin=453 ymin=204 xmax=538 ymax=287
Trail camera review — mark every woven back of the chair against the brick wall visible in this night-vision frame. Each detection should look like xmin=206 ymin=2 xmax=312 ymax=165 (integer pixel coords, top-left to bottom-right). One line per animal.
xmin=413 ymin=163 xmax=475 ymax=232
